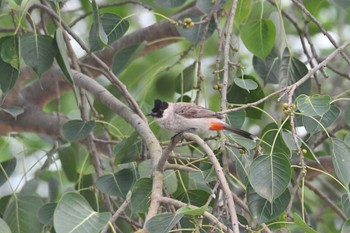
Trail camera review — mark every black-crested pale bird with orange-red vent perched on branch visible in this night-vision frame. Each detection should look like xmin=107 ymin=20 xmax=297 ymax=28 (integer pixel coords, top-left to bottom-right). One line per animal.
xmin=146 ymin=99 xmax=257 ymax=141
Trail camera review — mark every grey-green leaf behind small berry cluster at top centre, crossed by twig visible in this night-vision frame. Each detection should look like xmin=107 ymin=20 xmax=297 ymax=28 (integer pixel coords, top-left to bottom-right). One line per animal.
xmin=176 ymin=15 xmax=216 ymax=45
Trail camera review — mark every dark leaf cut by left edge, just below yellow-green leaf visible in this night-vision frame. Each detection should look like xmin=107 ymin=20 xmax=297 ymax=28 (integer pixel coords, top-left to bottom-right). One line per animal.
xmin=0 ymin=59 xmax=18 ymax=94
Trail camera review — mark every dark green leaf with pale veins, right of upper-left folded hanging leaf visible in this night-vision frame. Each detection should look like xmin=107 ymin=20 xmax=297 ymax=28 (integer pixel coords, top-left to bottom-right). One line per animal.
xmin=101 ymin=13 xmax=129 ymax=45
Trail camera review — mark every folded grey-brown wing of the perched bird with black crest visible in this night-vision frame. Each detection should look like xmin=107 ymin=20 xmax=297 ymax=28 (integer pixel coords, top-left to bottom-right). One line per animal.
xmin=175 ymin=103 xmax=218 ymax=118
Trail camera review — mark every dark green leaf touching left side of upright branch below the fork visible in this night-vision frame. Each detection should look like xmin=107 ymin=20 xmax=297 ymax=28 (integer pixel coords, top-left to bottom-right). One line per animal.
xmin=131 ymin=177 xmax=152 ymax=213
